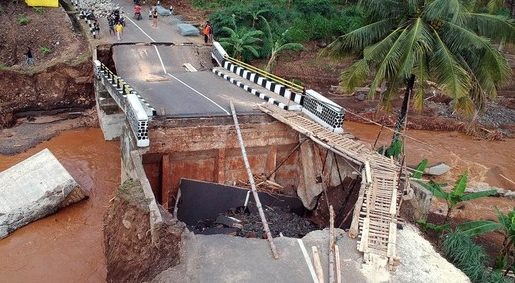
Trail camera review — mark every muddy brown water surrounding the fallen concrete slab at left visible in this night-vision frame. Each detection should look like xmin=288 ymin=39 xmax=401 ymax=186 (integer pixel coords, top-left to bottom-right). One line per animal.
xmin=0 ymin=129 xmax=120 ymax=282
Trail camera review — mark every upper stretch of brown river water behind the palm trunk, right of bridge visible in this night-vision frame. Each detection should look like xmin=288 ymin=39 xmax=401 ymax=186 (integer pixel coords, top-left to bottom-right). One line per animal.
xmin=344 ymin=122 xmax=515 ymax=190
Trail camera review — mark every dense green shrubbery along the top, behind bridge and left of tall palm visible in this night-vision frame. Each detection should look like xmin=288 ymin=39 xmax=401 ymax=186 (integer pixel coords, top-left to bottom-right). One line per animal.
xmin=202 ymin=0 xmax=365 ymax=62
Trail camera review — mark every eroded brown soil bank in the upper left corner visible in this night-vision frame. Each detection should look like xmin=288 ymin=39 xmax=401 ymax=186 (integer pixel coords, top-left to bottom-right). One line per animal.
xmin=0 ymin=1 xmax=95 ymax=128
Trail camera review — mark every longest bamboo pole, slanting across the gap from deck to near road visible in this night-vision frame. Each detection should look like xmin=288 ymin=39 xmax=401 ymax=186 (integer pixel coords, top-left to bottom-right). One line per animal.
xmin=230 ymin=101 xmax=279 ymax=259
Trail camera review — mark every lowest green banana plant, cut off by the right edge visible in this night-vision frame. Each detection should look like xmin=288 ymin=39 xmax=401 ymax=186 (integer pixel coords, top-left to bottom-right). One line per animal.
xmin=457 ymin=210 xmax=515 ymax=275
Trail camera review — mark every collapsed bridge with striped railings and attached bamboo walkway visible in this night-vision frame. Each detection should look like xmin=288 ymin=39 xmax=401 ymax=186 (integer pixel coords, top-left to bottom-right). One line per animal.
xmin=95 ymin=37 xmax=401 ymax=280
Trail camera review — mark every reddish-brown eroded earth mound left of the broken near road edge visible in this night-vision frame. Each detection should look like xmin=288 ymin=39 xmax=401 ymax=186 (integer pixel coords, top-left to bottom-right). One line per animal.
xmin=104 ymin=180 xmax=185 ymax=282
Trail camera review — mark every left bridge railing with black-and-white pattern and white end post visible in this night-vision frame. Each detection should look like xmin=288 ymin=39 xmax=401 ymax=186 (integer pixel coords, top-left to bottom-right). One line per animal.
xmin=95 ymin=60 xmax=150 ymax=147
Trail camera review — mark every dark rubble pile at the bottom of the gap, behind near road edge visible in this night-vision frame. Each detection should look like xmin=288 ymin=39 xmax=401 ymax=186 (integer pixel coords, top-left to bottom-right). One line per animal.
xmin=189 ymin=203 xmax=318 ymax=238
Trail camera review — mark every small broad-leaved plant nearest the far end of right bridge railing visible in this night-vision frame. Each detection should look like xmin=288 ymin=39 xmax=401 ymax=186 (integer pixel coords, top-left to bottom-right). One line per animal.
xmin=219 ymin=27 xmax=263 ymax=60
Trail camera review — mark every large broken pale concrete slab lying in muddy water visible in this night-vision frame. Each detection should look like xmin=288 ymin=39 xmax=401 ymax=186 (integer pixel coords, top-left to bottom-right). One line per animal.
xmin=0 ymin=149 xmax=86 ymax=239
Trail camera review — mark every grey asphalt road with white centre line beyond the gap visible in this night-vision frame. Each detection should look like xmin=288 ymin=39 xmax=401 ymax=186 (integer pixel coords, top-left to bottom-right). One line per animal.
xmin=104 ymin=1 xmax=263 ymax=117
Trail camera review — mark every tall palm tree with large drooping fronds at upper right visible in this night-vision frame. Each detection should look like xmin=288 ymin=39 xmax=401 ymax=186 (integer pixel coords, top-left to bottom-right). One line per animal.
xmin=322 ymin=0 xmax=515 ymax=140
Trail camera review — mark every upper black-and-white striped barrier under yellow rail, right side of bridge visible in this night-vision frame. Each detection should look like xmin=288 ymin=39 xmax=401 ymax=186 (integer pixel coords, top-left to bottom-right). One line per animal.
xmin=223 ymin=61 xmax=304 ymax=105
